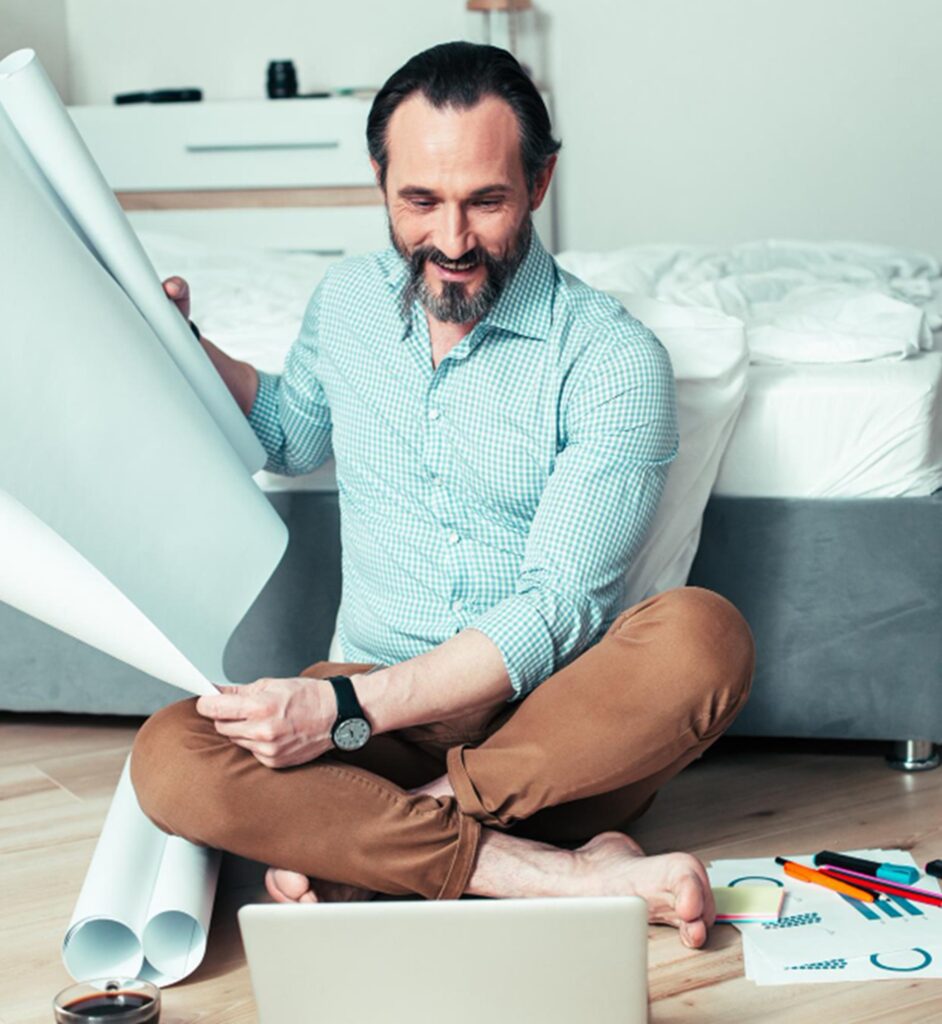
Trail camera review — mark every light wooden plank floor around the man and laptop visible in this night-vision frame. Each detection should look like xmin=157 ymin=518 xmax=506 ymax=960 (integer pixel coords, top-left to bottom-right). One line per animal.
xmin=0 ymin=715 xmax=942 ymax=1024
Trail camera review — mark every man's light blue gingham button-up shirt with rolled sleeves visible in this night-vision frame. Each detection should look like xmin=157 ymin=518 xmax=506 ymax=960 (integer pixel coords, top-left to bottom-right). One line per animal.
xmin=249 ymin=234 xmax=678 ymax=700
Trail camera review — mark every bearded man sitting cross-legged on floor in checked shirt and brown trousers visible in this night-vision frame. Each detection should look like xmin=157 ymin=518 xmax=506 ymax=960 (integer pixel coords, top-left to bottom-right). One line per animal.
xmin=131 ymin=43 xmax=754 ymax=946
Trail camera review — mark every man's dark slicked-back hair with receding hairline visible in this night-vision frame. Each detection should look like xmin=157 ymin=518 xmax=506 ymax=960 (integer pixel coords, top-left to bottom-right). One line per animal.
xmin=367 ymin=43 xmax=561 ymax=188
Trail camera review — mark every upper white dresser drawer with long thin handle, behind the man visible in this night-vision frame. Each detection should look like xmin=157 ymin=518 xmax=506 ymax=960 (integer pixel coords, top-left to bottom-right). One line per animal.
xmin=70 ymin=96 xmax=374 ymax=191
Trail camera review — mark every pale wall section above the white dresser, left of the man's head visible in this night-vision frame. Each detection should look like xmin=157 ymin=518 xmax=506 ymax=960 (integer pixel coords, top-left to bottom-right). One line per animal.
xmin=61 ymin=0 xmax=465 ymax=103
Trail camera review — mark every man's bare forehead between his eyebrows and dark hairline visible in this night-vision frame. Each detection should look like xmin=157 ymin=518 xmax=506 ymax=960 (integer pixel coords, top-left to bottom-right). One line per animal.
xmin=386 ymin=93 xmax=523 ymax=185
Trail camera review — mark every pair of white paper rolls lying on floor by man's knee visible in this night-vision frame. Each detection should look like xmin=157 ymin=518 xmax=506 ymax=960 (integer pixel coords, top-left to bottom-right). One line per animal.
xmin=62 ymin=762 xmax=219 ymax=985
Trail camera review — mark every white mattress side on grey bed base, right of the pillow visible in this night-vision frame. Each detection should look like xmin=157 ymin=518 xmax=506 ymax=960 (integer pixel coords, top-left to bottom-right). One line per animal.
xmin=714 ymin=351 xmax=942 ymax=498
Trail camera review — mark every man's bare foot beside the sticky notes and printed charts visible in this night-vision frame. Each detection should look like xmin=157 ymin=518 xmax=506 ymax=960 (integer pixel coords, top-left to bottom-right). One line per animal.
xmin=573 ymin=831 xmax=716 ymax=948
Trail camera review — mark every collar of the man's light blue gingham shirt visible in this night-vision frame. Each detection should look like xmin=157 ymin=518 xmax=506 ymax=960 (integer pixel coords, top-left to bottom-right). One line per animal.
xmin=384 ymin=230 xmax=556 ymax=341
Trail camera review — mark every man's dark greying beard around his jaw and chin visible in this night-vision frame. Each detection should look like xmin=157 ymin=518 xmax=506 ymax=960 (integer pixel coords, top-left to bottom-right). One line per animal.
xmin=389 ymin=215 xmax=533 ymax=324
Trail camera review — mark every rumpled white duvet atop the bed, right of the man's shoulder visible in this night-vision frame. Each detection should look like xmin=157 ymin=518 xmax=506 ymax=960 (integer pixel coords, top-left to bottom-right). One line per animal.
xmin=558 ymin=241 xmax=942 ymax=362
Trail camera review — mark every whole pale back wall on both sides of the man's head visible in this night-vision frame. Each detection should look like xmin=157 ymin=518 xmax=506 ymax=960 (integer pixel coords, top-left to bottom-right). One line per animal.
xmin=49 ymin=0 xmax=942 ymax=256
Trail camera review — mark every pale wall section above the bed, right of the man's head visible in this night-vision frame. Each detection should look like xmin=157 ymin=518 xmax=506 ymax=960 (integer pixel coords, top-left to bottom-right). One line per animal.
xmin=540 ymin=0 xmax=942 ymax=256
